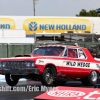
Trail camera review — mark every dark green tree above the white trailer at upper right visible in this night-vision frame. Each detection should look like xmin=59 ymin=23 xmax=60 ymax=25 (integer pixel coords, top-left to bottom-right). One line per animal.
xmin=76 ymin=9 xmax=100 ymax=17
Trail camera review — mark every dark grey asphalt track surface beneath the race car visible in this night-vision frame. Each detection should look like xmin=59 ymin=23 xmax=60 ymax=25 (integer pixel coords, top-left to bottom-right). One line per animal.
xmin=0 ymin=81 xmax=93 ymax=100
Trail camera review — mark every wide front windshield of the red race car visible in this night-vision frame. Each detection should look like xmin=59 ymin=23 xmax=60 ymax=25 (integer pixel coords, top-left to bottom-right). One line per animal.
xmin=31 ymin=47 xmax=64 ymax=56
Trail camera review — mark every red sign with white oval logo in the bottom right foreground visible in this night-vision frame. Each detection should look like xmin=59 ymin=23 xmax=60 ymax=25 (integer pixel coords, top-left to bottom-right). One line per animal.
xmin=35 ymin=87 xmax=100 ymax=100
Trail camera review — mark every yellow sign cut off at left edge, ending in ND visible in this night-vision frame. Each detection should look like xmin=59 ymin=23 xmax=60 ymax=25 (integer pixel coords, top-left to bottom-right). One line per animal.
xmin=0 ymin=18 xmax=15 ymax=29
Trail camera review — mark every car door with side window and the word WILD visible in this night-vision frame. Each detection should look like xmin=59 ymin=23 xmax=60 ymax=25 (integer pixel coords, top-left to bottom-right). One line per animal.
xmin=62 ymin=48 xmax=80 ymax=78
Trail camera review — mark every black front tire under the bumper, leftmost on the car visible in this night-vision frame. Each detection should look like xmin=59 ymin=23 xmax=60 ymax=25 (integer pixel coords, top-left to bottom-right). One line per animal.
xmin=5 ymin=74 xmax=19 ymax=86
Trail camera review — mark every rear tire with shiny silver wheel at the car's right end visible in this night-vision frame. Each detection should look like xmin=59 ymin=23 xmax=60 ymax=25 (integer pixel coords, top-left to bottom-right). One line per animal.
xmin=81 ymin=71 xmax=98 ymax=86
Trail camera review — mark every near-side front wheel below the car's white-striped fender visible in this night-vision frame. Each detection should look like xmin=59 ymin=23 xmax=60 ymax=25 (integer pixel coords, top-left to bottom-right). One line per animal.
xmin=41 ymin=67 xmax=54 ymax=86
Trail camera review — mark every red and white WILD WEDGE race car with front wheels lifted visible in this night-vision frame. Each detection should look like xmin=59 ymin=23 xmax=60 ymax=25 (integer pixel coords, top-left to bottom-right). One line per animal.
xmin=0 ymin=45 xmax=100 ymax=86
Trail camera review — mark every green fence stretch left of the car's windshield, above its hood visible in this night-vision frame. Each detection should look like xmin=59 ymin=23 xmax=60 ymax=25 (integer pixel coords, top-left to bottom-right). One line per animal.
xmin=0 ymin=44 xmax=38 ymax=58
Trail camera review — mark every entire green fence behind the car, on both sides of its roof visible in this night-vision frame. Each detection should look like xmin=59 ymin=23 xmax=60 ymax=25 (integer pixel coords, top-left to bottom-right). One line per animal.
xmin=0 ymin=42 xmax=100 ymax=58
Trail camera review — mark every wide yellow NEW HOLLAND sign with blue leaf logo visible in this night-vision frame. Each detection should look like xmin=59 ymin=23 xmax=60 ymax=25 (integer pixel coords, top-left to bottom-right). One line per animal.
xmin=23 ymin=18 xmax=91 ymax=35
